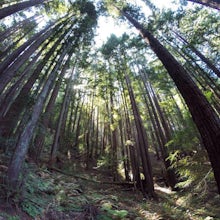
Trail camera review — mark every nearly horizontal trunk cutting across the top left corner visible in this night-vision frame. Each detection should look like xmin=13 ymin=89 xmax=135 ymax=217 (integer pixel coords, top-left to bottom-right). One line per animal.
xmin=0 ymin=0 xmax=48 ymax=19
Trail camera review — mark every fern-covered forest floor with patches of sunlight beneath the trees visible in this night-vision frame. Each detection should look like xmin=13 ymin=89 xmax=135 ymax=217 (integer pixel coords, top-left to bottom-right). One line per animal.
xmin=0 ymin=156 xmax=220 ymax=220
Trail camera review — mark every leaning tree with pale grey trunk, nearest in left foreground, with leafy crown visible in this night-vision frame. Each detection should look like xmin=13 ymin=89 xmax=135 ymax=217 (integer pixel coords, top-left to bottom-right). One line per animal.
xmin=6 ymin=2 xmax=97 ymax=189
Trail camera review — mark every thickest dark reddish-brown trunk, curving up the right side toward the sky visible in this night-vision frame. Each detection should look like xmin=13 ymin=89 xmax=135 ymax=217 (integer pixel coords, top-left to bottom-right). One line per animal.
xmin=121 ymin=9 xmax=220 ymax=194
